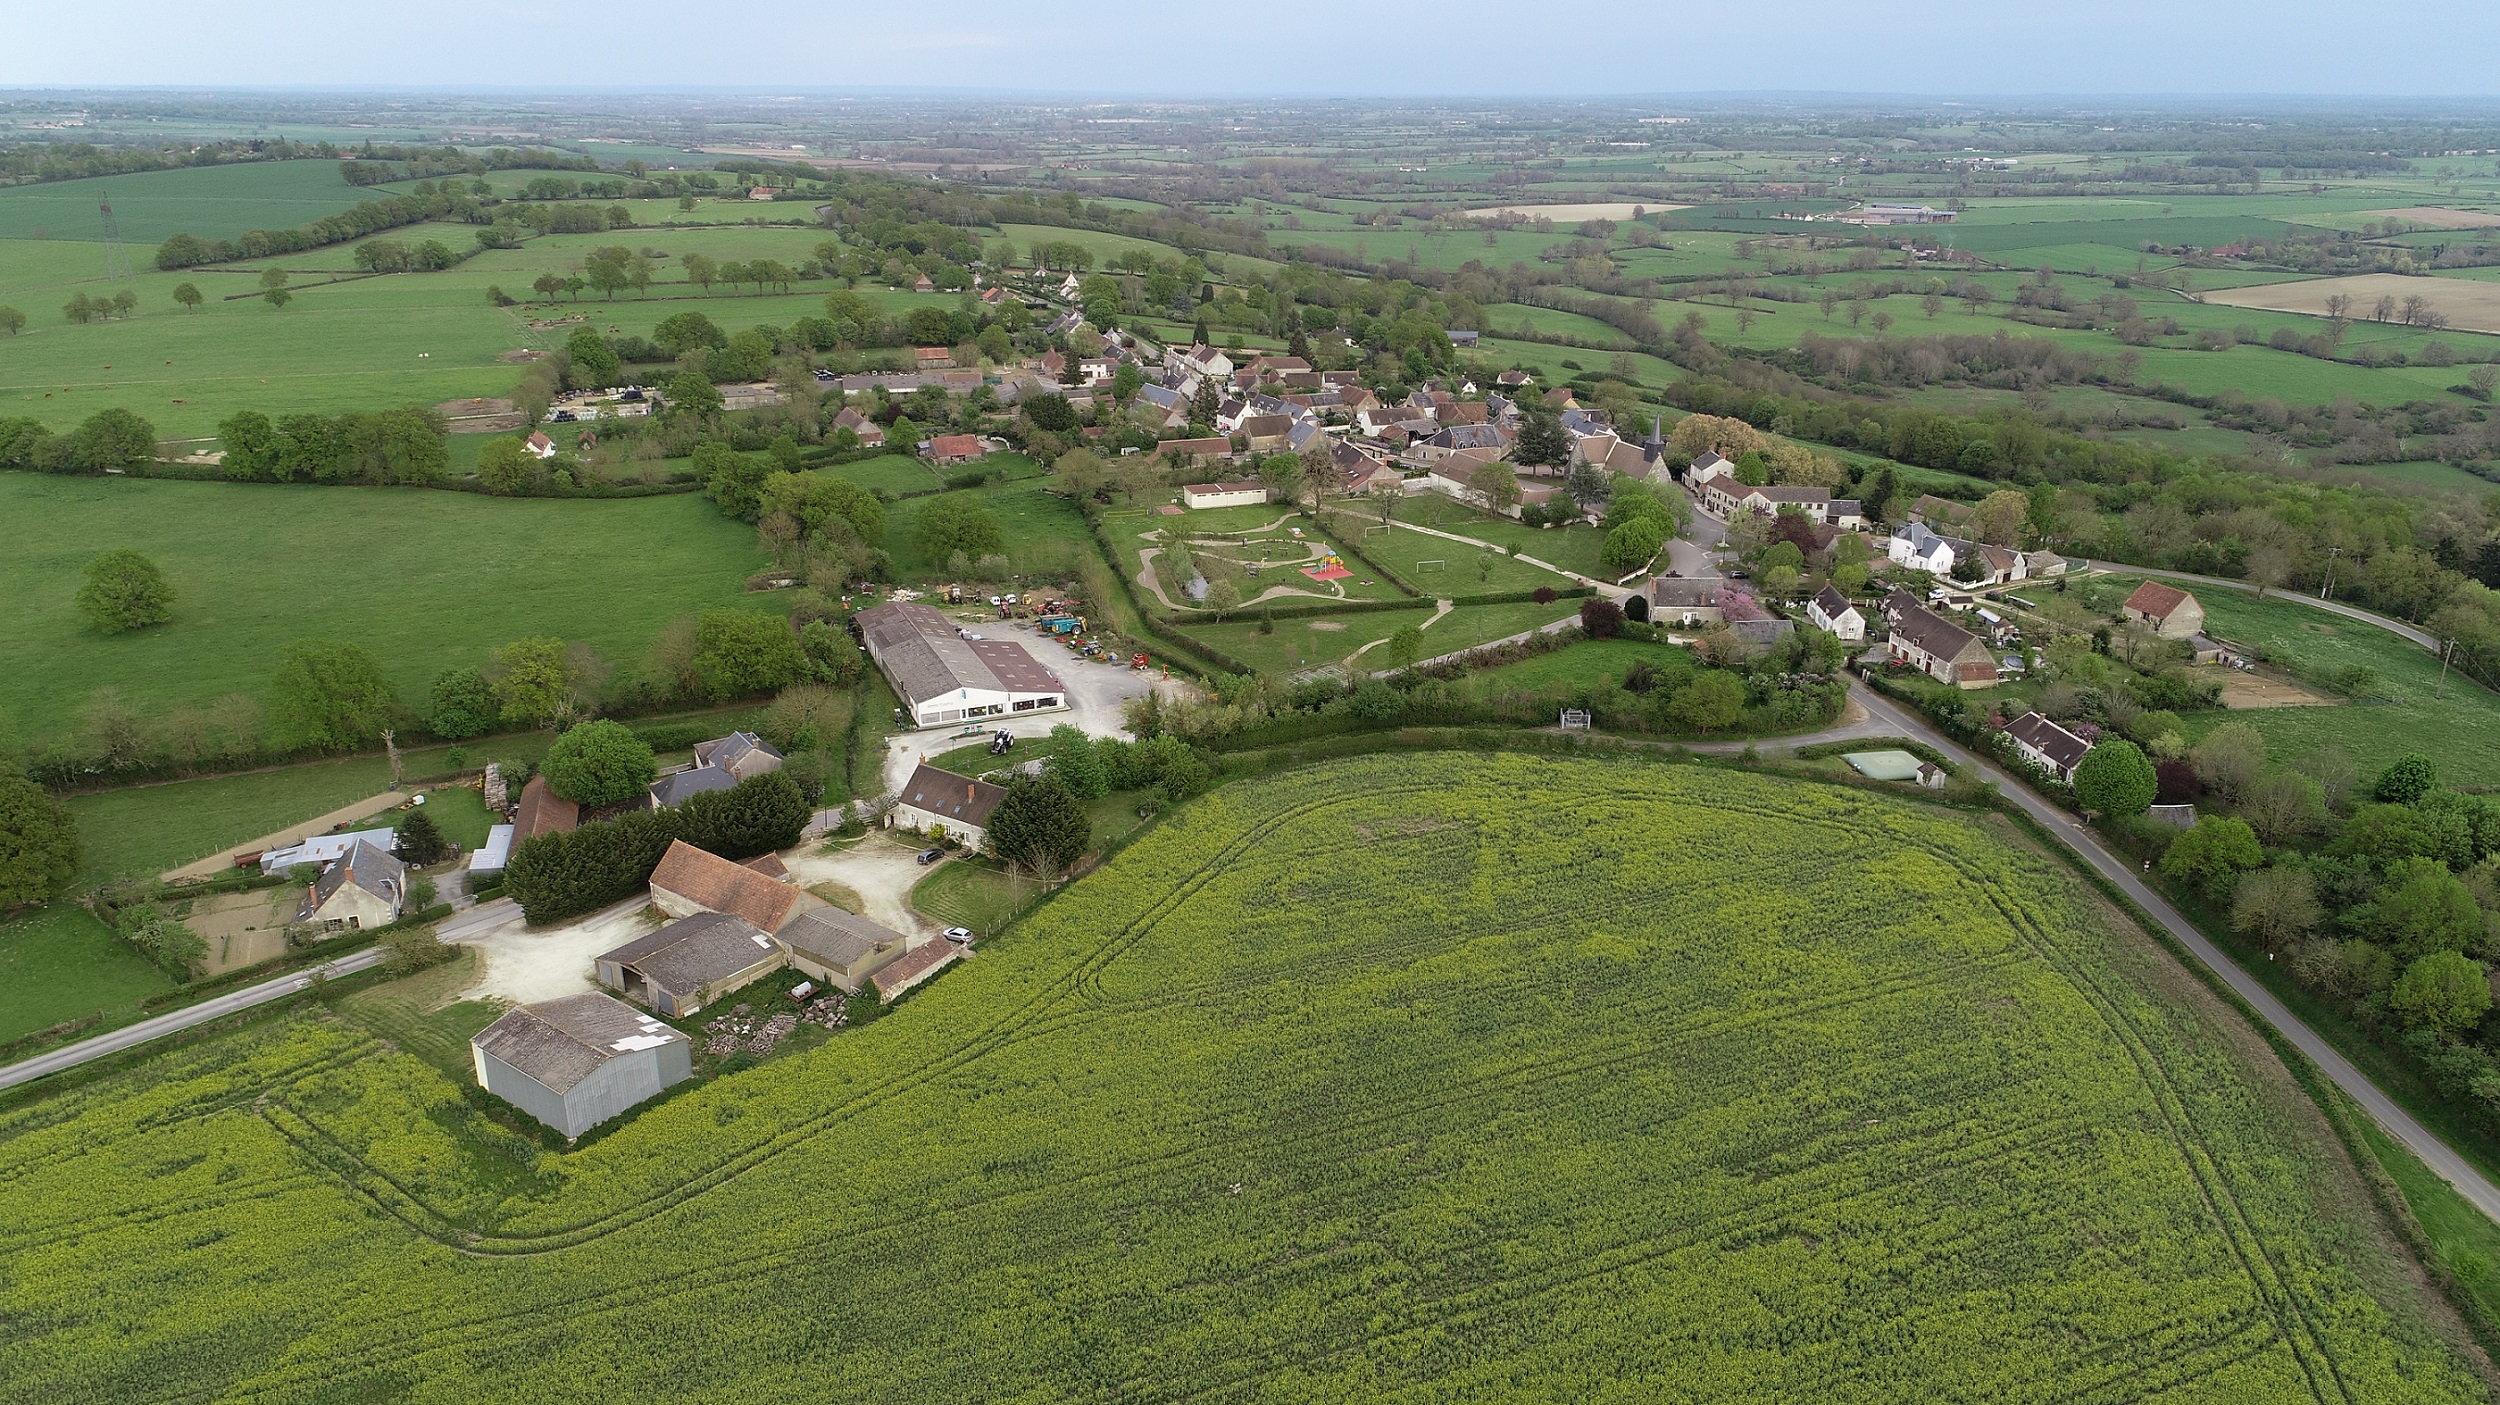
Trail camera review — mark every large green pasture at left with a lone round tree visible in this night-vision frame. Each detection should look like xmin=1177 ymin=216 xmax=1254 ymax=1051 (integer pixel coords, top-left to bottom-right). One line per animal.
xmin=0 ymin=473 xmax=775 ymax=745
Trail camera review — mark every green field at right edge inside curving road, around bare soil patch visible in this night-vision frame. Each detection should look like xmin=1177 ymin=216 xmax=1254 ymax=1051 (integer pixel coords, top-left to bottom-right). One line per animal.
xmin=2110 ymin=575 xmax=2500 ymax=788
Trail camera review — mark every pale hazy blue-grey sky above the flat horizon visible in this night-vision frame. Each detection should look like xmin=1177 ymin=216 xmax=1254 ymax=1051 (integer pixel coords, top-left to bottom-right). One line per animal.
xmin=14 ymin=0 xmax=2500 ymax=98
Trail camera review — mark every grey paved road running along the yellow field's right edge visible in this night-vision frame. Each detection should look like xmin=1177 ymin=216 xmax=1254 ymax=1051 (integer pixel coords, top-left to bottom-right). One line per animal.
xmin=1850 ymin=675 xmax=2500 ymax=1220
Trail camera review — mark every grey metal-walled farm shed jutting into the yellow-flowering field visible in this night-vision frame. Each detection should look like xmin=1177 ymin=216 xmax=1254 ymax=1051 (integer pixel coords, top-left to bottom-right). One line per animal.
xmin=470 ymin=993 xmax=695 ymax=1140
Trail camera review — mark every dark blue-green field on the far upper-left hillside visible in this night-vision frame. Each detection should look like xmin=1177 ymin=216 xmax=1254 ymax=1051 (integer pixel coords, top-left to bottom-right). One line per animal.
xmin=0 ymin=160 xmax=375 ymax=243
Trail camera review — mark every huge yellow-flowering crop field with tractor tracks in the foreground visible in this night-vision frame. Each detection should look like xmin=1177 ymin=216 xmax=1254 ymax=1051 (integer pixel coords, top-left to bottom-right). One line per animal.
xmin=0 ymin=755 xmax=2483 ymax=1403
